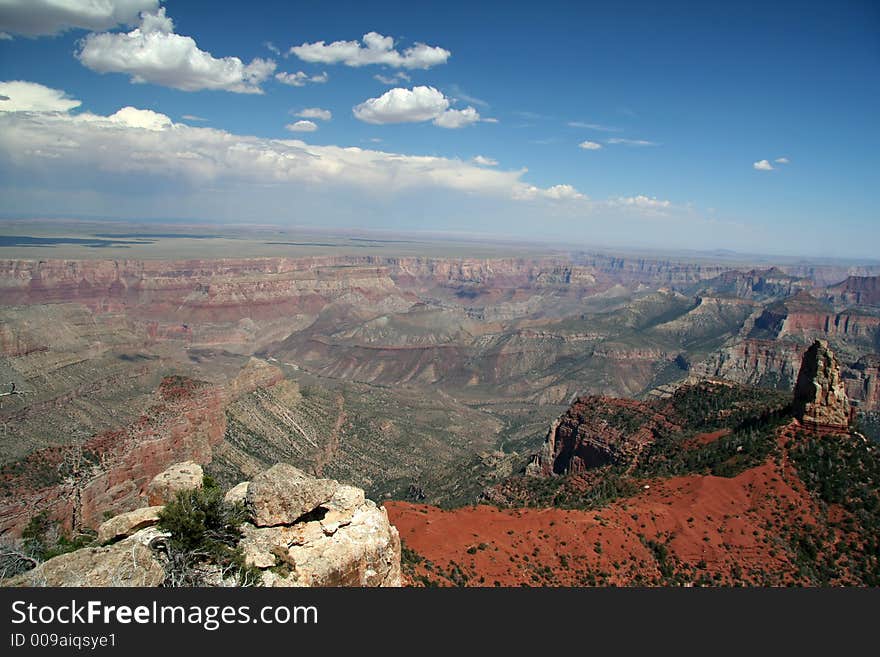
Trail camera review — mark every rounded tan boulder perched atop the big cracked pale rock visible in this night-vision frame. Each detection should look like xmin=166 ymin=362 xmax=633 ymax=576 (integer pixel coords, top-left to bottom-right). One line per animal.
xmin=245 ymin=463 xmax=339 ymax=527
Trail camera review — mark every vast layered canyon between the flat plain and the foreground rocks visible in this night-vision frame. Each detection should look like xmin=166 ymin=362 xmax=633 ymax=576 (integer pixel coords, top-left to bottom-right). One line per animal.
xmin=0 ymin=245 xmax=880 ymax=576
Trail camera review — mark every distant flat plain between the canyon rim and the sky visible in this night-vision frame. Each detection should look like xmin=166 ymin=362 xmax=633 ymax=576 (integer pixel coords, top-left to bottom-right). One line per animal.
xmin=0 ymin=219 xmax=880 ymax=269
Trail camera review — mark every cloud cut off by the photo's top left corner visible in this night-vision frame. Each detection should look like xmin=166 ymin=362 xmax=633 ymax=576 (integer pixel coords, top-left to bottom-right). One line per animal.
xmin=0 ymin=0 xmax=159 ymax=37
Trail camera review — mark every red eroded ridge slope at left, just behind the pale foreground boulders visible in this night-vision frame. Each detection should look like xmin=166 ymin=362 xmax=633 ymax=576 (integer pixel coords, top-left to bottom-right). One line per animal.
xmin=0 ymin=359 xmax=282 ymax=535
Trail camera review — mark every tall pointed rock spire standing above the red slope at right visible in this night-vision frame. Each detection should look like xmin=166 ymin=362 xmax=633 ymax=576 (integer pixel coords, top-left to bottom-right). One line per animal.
xmin=794 ymin=340 xmax=850 ymax=430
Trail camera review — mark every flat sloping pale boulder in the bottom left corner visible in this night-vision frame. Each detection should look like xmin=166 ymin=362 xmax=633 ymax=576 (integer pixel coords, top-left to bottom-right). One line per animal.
xmin=3 ymin=536 xmax=165 ymax=587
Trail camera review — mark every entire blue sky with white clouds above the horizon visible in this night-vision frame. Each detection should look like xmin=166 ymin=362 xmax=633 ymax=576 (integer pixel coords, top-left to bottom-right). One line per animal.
xmin=0 ymin=0 xmax=880 ymax=258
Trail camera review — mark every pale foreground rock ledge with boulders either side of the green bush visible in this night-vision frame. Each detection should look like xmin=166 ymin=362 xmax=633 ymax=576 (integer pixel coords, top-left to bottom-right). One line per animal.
xmin=0 ymin=463 xmax=401 ymax=587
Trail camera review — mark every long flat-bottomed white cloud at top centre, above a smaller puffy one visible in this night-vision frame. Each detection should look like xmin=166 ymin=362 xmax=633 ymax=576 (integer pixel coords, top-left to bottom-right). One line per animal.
xmin=290 ymin=32 xmax=452 ymax=69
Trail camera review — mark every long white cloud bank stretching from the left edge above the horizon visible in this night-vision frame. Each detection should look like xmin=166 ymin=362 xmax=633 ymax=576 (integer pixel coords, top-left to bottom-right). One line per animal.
xmin=0 ymin=81 xmax=586 ymax=203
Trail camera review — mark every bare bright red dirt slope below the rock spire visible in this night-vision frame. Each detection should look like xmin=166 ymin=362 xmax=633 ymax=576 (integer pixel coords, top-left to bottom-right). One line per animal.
xmin=385 ymin=438 xmax=816 ymax=586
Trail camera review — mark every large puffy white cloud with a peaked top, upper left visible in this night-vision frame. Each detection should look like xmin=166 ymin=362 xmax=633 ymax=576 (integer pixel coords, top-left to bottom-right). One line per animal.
xmin=76 ymin=7 xmax=275 ymax=94
